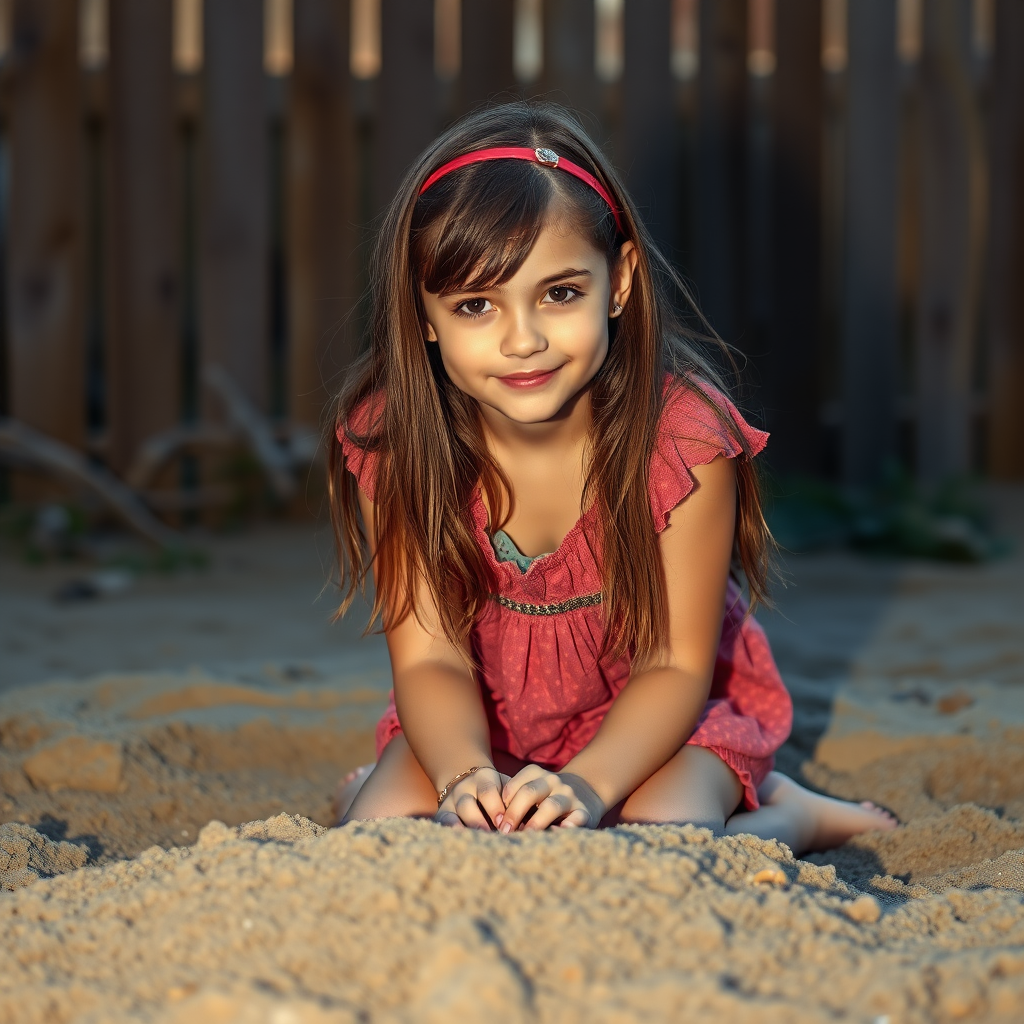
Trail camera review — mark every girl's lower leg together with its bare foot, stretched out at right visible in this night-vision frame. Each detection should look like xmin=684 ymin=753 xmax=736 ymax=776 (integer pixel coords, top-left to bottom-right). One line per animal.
xmin=725 ymin=771 xmax=898 ymax=857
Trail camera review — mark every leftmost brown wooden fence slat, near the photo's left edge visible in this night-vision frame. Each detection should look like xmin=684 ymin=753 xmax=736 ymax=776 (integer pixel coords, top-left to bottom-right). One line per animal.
xmin=8 ymin=0 xmax=85 ymax=449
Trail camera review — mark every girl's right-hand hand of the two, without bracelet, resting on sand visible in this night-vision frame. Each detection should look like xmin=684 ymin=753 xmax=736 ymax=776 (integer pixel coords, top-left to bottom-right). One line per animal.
xmin=493 ymin=765 xmax=606 ymax=833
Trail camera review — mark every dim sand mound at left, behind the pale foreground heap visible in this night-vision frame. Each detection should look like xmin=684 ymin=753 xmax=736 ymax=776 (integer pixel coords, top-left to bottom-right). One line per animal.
xmin=0 ymin=671 xmax=386 ymax=863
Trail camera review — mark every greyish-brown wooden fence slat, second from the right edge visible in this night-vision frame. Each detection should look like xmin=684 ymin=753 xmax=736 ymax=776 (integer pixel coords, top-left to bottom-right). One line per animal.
xmin=915 ymin=0 xmax=981 ymax=481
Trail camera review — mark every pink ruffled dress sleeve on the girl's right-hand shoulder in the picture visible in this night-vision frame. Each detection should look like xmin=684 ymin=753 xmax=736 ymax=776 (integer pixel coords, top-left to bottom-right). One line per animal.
xmin=649 ymin=381 xmax=768 ymax=532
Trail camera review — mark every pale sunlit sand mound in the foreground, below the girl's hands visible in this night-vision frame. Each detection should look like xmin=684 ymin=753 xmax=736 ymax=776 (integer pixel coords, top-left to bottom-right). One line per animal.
xmin=0 ymin=815 xmax=1024 ymax=1024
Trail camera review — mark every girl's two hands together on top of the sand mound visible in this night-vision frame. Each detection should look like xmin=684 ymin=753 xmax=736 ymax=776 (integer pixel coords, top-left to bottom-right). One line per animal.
xmin=434 ymin=765 xmax=606 ymax=834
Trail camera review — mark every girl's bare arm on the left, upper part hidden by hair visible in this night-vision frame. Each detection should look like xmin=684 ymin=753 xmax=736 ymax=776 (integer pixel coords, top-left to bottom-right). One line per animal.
xmin=359 ymin=492 xmax=504 ymax=823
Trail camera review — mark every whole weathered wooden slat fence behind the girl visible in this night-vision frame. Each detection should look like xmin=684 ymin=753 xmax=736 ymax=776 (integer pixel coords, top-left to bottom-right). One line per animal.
xmin=0 ymin=0 xmax=1024 ymax=536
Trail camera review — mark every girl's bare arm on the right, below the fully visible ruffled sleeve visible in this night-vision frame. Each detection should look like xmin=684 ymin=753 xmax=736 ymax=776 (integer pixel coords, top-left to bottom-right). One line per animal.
xmin=497 ymin=457 xmax=736 ymax=827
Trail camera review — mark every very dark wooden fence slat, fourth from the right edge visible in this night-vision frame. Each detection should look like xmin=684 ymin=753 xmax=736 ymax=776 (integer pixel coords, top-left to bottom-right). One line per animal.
xmin=761 ymin=0 xmax=824 ymax=473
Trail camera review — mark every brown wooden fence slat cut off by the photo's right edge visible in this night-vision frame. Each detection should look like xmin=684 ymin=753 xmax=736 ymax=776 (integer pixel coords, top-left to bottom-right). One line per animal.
xmin=987 ymin=0 xmax=1024 ymax=480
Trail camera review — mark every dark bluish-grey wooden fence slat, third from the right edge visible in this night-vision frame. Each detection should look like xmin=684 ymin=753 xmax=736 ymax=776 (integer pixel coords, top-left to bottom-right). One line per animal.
xmin=842 ymin=0 xmax=899 ymax=484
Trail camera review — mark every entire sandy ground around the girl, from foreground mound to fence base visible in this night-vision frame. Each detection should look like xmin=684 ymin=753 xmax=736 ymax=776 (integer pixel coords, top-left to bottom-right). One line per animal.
xmin=0 ymin=490 xmax=1024 ymax=1024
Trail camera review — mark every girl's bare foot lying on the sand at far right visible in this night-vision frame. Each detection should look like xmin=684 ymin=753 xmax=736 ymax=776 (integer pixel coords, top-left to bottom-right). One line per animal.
xmin=755 ymin=771 xmax=899 ymax=855
